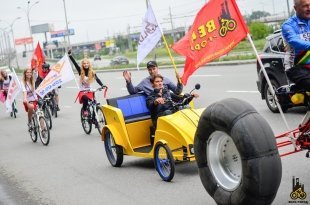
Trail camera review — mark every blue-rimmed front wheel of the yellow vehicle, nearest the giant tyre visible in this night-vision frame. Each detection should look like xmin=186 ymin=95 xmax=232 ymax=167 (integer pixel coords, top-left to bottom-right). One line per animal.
xmin=154 ymin=142 xmax=175 ymax=182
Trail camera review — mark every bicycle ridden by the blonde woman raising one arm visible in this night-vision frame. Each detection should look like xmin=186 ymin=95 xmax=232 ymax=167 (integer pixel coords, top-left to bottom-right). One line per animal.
xmin=81 ymin=87 xmax=107 ymax=135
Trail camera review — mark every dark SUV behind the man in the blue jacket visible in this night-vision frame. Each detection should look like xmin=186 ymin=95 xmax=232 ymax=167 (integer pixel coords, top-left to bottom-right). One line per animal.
xmin=256 ymin=30 xmax=289 ymax=112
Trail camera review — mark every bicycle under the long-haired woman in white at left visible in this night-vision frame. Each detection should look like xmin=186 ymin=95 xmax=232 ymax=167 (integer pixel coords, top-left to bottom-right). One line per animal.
xmin=28 ymin=100 xmax=50 ymax=146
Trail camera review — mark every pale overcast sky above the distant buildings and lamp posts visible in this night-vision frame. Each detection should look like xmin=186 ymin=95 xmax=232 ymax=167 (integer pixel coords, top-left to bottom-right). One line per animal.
xmin=0 ymin=0 xmax=293 ymax=49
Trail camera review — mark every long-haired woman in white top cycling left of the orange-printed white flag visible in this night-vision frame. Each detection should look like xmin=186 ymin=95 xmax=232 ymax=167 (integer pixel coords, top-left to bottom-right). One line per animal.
xmin=22 ymin=68 xmax=37 ymax=129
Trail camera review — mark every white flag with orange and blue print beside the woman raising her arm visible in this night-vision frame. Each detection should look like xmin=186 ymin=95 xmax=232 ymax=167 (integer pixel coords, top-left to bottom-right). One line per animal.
xmin=35 ymin=54 xmax=75 ymax=98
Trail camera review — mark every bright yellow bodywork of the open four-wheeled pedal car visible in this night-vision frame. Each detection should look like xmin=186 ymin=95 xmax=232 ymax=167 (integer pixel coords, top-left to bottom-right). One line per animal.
xmin=101 ymin=105 xmax=204 ymax=161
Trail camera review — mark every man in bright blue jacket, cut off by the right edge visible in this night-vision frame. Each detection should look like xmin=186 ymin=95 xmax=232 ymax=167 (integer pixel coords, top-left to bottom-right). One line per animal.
xmin=282 ymin=0 xmax=310 ymax=90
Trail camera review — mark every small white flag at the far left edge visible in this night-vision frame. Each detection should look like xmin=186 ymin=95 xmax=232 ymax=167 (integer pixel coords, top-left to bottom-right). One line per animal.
xmin=5 ymin=68 xmax=22 ymax=112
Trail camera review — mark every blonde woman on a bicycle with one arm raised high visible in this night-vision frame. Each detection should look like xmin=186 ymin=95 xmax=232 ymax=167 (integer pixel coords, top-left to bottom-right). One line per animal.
xmin=68 ymin=49 xmax=106 ymax=117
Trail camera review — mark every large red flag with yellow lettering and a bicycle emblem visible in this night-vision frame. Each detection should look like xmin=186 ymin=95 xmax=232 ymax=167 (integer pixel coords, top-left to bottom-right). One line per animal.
xmin=172 ymin=0 xmax=248 ymax=85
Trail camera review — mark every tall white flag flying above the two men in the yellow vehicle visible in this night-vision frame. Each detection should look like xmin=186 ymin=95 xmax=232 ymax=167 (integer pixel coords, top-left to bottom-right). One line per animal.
xmin=137 ymin=4 xmax=162 ymax=65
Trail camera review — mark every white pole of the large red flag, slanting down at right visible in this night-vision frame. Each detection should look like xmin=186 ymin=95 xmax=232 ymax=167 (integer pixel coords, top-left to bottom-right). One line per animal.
xmin=247 ymin=33 xmax=290 ymax=130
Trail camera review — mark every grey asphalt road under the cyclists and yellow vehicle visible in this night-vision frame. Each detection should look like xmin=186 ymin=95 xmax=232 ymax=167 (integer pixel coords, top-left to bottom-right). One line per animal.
xmin=0 ymin=64 xmax=310 ymax=205
